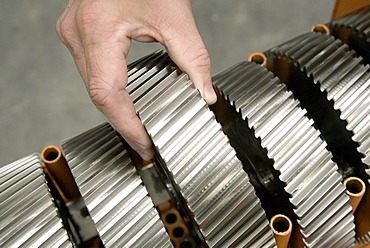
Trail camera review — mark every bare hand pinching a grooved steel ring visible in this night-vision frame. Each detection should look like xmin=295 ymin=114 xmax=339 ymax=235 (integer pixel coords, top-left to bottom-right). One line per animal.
xmin=57 ymin=0 xmax=216 ymax=160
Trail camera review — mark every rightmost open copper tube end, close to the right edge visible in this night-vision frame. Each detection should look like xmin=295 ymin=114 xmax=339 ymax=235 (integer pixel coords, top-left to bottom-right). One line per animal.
xmin=344 ymin=177 xmax=366 ymax=214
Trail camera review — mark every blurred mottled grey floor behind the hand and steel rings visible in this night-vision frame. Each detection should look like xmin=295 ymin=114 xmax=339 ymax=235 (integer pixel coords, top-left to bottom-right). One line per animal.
xmin=0 ymin=0 xmax=334 ymax=165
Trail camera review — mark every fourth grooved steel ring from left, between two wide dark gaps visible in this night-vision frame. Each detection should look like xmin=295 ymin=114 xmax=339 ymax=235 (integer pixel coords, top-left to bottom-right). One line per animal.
xmin=213 ymin=62 xmax=355 ymax=247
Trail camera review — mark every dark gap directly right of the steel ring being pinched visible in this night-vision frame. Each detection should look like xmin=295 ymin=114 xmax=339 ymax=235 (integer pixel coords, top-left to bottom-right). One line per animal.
xmin=210 ymin=90 xmax=297 ymax=232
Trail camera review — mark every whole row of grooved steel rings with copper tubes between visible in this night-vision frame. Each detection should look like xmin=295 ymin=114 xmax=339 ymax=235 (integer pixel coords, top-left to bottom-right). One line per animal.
xmin=0 ymin=7 xmax=370 ymax=247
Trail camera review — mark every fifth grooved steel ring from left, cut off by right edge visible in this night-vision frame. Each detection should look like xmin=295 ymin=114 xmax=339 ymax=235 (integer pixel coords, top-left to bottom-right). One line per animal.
xmin=267 ymin=33 xmax=370 ymax=180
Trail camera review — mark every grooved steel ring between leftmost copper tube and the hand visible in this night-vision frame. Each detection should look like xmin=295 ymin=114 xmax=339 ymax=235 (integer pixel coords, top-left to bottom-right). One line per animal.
xmin=62 ymin=123 xmax=171 ymax=247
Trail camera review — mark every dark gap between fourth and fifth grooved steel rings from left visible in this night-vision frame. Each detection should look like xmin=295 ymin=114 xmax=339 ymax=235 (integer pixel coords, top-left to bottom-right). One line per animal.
xmin=268 ymin=58 xmax=368 ymax=181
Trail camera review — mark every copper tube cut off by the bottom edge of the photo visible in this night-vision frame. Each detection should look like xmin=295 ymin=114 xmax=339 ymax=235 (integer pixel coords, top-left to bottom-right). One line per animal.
xmin=270 ymin=214 xmax=293 ymax=248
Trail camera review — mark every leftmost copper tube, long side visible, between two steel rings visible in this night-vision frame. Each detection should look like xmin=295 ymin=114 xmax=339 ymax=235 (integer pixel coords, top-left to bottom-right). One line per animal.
xmin=41 ymin=146 xmax=81 ymax=203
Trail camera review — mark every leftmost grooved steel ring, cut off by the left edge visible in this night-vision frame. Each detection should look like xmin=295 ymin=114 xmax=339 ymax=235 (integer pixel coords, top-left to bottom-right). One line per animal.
xmin=0 ymin=154 xmax=72 ymax=247
